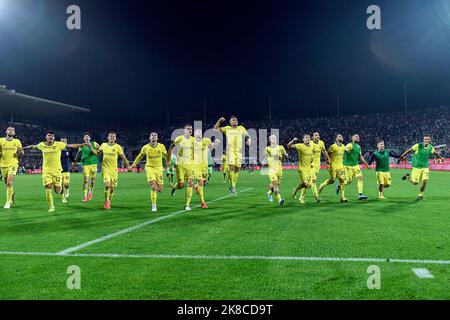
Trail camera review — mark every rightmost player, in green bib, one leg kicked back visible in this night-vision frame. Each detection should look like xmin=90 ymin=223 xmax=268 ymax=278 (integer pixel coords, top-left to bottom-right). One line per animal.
xmin=401 ymin=134 xmax=444 ymax=200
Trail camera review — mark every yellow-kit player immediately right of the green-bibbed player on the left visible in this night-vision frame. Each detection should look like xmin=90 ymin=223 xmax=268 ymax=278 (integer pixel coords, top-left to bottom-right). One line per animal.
xmin=88 ymin=131 xmax=131 ymax=210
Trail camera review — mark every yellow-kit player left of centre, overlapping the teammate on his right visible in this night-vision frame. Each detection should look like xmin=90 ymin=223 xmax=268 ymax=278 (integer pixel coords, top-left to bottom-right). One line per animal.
xmin=167 ymin=124 xmax=195 ymax=211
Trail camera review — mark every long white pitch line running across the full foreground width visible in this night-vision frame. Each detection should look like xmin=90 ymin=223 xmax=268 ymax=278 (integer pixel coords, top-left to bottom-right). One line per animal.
xmin=0 ymin=251 xmax=450 ymax=265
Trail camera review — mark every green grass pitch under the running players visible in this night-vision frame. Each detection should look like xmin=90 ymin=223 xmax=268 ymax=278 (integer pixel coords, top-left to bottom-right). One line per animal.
xmin=0 ymin=170 xmax=450 ymax=299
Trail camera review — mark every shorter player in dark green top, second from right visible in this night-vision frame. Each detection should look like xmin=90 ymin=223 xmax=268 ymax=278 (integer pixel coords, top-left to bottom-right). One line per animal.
xmin=369 ymin=140 xmax=400 ymax=200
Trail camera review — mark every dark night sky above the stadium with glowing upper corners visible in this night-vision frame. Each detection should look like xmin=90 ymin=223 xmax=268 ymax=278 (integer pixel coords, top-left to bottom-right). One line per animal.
xmin=0 ymin=0 xmax=450 ymax=123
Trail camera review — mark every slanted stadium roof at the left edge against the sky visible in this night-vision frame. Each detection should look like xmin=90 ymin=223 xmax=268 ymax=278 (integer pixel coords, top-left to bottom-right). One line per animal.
xmin=0 ymin=86 xmax=90 ymax=117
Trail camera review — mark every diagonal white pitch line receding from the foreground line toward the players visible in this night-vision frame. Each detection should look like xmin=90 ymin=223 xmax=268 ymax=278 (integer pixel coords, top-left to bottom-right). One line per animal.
xmin=57 ymin=187 xmax=253 ymax=255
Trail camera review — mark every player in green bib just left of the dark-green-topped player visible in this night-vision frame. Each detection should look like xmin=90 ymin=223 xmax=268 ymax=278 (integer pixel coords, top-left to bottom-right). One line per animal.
xmin=342 ymin=134 xmax=370 ymax=200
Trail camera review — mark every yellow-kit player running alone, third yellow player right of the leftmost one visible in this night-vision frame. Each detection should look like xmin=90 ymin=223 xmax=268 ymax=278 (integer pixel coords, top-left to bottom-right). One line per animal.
xmin=132 ymin=132 xmax=170 ymax=212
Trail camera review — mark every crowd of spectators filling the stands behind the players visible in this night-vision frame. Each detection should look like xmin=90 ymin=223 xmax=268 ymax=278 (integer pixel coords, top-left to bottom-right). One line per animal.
xmin=0 ymin=106 xmax=450 ymax=169
